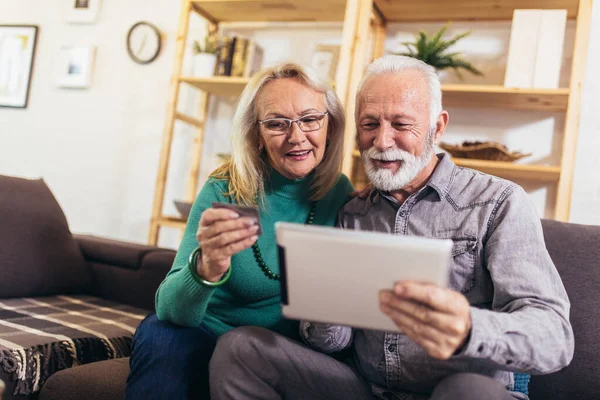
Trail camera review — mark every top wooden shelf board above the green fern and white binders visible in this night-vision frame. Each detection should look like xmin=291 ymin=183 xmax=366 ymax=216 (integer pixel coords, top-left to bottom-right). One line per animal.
xmin=374 ymin=0 xmax=579 ymax=22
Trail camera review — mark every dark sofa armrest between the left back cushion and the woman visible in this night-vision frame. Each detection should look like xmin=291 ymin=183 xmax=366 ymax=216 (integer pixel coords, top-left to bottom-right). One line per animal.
xmin=74 ymin=235 xmax=175 ymax=311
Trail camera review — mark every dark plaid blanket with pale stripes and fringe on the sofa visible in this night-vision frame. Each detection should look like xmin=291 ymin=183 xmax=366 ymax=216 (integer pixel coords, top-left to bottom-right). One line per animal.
xmin=0 ymin=296 xmax=148 ymax=395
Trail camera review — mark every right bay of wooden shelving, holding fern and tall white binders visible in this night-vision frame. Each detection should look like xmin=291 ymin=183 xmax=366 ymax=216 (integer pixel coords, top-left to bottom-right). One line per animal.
xmin=344 ymin=0 xmax=592 ymax=221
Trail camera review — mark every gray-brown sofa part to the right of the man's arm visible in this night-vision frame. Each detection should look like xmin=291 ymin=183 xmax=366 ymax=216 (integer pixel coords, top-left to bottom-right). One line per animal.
xmin=529 ymin=221 xmax=600 ymax=400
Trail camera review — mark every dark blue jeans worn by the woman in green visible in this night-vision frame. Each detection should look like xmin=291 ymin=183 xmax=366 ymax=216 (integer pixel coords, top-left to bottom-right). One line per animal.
xmin=125 ymin=314 xmax=217 ymax=400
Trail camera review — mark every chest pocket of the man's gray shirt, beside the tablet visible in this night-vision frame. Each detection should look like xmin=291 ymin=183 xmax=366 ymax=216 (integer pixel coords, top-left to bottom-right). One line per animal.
xmin=448 ymin=236 xmax=477 ymax=293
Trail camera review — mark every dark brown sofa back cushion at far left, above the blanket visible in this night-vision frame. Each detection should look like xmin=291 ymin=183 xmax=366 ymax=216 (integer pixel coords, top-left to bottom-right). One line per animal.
xmin=0 ymin=175 xmax=91 ymax=298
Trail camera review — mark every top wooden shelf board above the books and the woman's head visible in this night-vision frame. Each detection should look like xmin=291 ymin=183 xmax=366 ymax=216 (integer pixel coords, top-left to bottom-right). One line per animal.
xmin=192 ymin=0 xmax=346 ymax=23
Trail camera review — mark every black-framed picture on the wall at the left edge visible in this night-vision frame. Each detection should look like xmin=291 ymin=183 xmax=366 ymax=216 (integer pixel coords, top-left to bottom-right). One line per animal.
xmin=0 ymin=25 xmax=38 ymax=108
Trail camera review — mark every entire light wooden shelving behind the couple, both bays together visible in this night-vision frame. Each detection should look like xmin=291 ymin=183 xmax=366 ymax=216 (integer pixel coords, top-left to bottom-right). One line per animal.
xmin=149 ymin=0 xmax=593 ymax=244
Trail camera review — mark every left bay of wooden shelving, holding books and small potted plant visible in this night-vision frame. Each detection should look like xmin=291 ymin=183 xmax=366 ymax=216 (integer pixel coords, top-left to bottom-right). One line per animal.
xmin=148 ymin=0 xmax=360 ymax=245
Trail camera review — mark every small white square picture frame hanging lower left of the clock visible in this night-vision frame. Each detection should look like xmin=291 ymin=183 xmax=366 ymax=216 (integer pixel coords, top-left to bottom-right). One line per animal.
xmin=56 ymin=46 xmax=96 ymax=89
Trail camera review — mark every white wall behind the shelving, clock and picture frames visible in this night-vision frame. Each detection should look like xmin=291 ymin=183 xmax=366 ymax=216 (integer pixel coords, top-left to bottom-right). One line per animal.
xmin=0 ymin=0 xmax=600 ymax=247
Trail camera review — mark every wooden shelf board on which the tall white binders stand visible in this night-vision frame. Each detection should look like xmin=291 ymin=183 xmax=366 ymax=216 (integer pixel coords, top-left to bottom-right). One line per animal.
xmin=442 ymin=85 xmax=569 ymax=111
